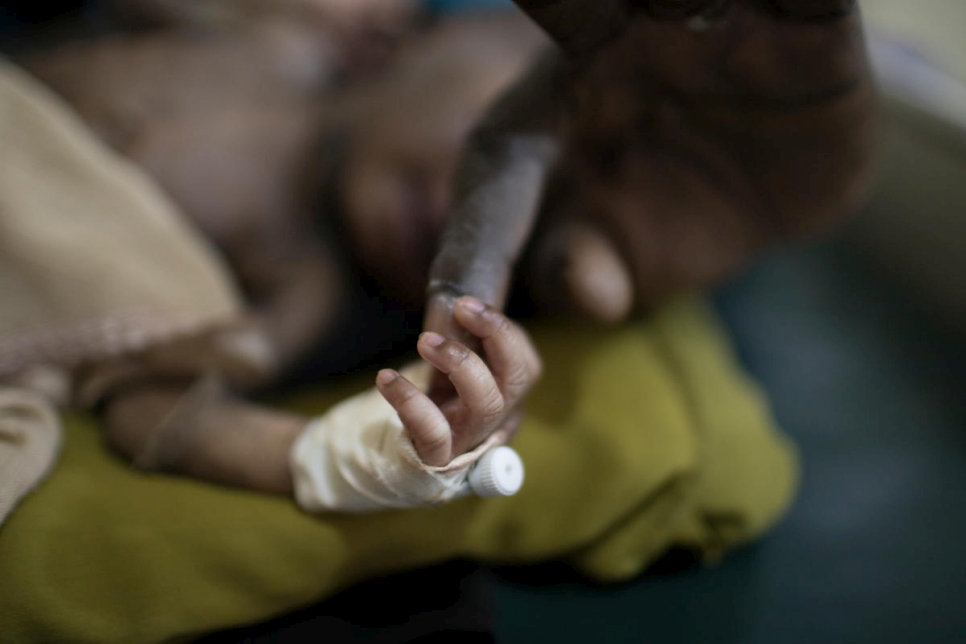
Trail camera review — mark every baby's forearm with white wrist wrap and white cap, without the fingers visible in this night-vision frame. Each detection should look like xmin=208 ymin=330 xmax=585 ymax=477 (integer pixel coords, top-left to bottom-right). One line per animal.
xmin=104 ymin=369 xmax=522 ymax=512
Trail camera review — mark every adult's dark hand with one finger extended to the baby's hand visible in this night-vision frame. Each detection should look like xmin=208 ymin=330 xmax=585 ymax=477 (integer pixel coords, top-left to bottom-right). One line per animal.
xmin=425 ymin=0 xmax=876 ymax=456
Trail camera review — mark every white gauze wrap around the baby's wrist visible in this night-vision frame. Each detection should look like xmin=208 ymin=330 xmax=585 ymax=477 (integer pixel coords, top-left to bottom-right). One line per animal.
xmin=289 ymin=363 xmax=506 ymax=512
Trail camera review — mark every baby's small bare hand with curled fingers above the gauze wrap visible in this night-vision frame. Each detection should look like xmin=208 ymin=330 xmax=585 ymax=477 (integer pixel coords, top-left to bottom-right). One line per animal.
xmin=376 ymin=297 xmax=543 ymax=466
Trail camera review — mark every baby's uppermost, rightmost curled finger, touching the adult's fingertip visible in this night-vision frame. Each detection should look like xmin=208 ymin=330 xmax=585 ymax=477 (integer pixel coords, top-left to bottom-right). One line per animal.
xmin=454 ymin=297 xmax=543 ymax=407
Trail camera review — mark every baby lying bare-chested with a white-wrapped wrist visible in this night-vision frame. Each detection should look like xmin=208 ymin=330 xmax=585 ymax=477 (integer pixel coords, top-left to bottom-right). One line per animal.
xmin=13 ymin=11 xmax=541 ymax=509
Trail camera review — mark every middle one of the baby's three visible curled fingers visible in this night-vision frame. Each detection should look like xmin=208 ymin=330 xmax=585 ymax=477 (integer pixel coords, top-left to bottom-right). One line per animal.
xmin=416 ymin=333 xmax=504 ymax=432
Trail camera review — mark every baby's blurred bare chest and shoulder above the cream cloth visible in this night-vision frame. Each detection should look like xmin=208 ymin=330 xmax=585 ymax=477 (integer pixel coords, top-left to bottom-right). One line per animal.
xmin=21 ymin=23 xmax=370 ymax=378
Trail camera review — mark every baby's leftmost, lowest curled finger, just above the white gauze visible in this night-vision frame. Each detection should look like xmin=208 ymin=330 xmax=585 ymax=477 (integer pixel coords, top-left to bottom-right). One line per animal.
xmin=376 ymin=369 xmax=453 ymax=465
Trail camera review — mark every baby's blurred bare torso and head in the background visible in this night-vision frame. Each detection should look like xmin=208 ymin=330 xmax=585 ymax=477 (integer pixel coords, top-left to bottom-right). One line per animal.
xmin=21 ymin=13 xmax=547 ymax=378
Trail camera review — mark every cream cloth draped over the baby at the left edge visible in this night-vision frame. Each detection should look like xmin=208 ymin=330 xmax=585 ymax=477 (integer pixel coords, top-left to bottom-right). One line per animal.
xmin=0 ymin=60 xmax=264 ymax=523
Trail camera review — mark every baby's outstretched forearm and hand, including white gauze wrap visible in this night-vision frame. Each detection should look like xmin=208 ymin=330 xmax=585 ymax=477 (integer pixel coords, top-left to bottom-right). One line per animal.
xmin=104 ymin=298 xmax=541 ymax=511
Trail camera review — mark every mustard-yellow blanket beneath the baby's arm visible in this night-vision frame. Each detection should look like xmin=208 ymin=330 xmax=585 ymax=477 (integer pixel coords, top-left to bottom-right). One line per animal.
xmin=0 ymin=300 xmax=797 ymax=643
